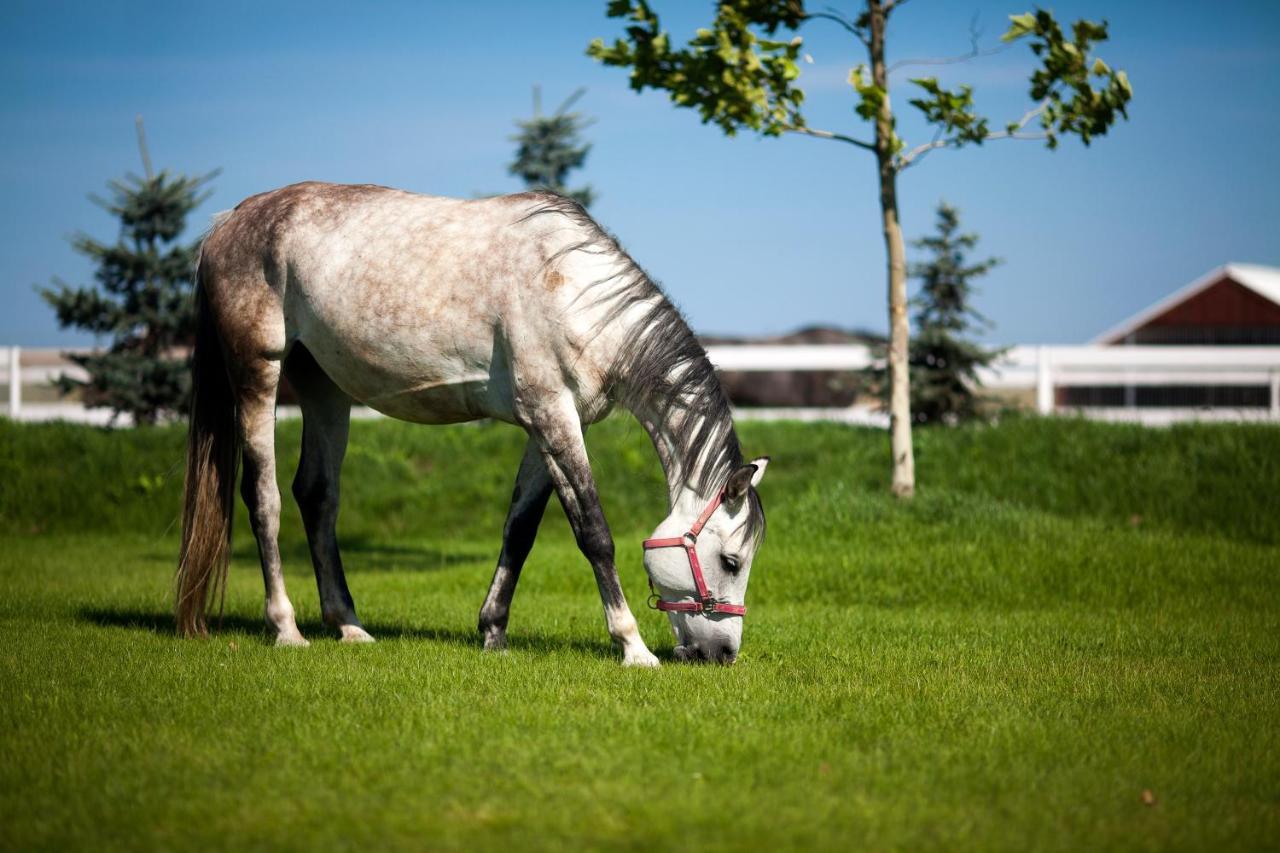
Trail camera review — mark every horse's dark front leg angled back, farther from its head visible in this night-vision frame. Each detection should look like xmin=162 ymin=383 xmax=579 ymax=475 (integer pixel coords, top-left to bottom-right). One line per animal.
xmin=480 ymin=438 xmax=552 ymax=651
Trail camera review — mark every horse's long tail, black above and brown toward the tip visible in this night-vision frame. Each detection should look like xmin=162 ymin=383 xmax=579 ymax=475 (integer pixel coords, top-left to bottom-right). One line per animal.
xmin=175 ymin=264 xmax=239 ymax=637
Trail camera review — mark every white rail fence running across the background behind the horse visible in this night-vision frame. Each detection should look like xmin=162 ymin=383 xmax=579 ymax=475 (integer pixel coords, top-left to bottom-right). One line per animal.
xmin=0 ymin=345 xmax=1280 ymax=425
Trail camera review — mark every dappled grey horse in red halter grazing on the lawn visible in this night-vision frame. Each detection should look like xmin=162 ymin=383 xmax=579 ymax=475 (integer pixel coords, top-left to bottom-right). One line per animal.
xmin=177 ymin=183 xmax=768 ymax=666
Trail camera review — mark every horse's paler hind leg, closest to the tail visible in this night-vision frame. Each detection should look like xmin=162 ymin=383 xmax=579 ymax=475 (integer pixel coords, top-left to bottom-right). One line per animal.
xmin=234 ymin=357 xmax=307 ymax=646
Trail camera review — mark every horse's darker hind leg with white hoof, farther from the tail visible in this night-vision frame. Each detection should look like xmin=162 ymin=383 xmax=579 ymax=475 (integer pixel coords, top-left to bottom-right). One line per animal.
xmin=284 ymin=345 xmax=374 ymax=643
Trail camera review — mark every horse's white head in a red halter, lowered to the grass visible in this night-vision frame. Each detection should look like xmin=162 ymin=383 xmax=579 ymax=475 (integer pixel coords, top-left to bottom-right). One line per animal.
xmin=644 ymin=456 xmax=769 ymax=663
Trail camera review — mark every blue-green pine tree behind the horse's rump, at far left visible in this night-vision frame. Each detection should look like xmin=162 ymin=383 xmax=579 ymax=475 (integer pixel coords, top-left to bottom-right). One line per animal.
xmin=41 ymin=119 xmax=216 ymax=424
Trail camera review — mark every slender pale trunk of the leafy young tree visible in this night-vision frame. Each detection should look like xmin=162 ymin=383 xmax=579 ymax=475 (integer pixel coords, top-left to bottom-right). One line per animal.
xmin=867 ymin=0 xmax=915 ymax=498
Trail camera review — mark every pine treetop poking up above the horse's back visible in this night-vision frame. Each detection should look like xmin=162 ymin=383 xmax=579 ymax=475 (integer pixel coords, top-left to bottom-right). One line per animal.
xmin=507 ymin=86 xmax=595 ymax=207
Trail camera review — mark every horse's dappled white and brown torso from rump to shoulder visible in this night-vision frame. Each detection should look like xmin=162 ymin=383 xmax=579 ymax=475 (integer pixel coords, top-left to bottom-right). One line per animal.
xmin=201 ymin=183 xmax=614 ymax=423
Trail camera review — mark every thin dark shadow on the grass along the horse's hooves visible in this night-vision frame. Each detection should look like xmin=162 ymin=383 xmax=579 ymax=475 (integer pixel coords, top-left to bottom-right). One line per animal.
xmin=78 ymin=607 xmax=629 ymax=658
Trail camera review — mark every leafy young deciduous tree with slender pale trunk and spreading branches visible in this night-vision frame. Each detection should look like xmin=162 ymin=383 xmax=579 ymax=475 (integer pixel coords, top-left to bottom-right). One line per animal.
xmin=588 ymin=0 xmax=1132 ymax=497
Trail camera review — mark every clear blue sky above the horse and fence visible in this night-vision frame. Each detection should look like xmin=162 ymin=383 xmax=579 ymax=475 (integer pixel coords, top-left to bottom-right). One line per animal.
xmin=0 ymin=0 xmax=1280 ymax=346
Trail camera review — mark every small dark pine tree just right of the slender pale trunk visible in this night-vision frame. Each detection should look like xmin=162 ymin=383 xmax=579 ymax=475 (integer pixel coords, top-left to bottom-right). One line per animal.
xmin=909 ymin=202 xmax=1002 ymax=423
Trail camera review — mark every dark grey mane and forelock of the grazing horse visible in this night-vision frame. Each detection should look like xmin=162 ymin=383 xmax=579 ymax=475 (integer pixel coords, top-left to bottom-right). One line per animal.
xmin=521 ymin=191 xmax=764 ymax=537
